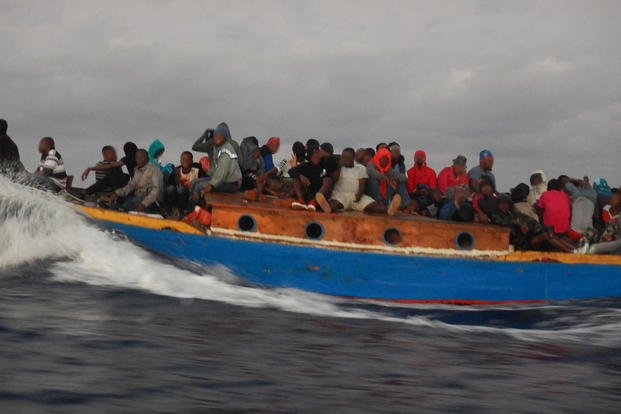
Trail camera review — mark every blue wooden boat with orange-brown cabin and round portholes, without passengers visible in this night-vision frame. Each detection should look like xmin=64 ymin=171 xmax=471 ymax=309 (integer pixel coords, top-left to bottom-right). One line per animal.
xmin=80 ymin=195 xmax=621 ymax=304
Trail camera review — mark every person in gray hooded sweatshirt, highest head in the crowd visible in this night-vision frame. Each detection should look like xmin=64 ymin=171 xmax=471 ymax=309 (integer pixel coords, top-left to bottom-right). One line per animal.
xmin=192 ymin=122 xmax=242 ymax=202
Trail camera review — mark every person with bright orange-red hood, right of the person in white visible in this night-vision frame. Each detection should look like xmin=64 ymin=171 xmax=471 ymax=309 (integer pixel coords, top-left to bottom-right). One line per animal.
xmin=366 ymin=148 xmax=409 ymax=207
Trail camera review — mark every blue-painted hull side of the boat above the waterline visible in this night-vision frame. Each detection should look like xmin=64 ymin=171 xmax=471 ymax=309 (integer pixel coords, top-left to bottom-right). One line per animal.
xmin=99 ymin=222 xmax=621 ymax=303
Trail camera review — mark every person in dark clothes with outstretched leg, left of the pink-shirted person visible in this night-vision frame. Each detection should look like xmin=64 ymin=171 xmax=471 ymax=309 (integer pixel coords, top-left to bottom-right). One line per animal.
xmin=490 ymin=194 xmax=573 ymax=253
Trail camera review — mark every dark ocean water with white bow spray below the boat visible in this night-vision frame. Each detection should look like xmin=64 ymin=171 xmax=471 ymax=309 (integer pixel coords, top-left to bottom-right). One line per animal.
xmin=0 ymin=179 xmax=621 ymax=413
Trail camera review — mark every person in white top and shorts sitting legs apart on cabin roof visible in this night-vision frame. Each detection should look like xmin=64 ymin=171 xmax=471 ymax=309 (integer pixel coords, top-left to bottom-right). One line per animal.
xmin=316 ymin=148 xmax=401 ymax=216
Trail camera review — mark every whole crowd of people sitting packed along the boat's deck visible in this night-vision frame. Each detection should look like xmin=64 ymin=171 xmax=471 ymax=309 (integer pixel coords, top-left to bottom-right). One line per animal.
xmin=0 ymin=120 xmax=621 ymax=254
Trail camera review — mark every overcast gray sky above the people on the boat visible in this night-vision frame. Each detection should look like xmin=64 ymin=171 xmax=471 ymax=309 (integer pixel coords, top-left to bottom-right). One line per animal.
xmin=0 ymin=0 xmax=621 ymax=189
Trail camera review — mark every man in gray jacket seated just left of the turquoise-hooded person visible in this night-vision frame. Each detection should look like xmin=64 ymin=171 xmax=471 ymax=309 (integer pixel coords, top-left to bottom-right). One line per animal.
xmin=100 ymin=149 xmax=164 ymax=212
